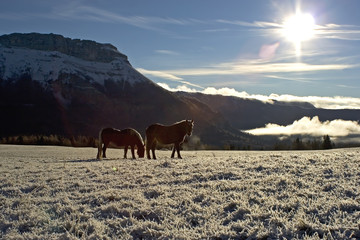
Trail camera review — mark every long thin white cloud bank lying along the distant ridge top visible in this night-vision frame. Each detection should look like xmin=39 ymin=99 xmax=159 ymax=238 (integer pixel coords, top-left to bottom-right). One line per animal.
xmin=158 ymin=83 xmax=360 ymax=109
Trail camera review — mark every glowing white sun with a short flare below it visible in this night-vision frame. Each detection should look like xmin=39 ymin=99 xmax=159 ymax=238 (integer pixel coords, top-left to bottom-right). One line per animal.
xmin=282 ymin=13 xmax=315 ymax=55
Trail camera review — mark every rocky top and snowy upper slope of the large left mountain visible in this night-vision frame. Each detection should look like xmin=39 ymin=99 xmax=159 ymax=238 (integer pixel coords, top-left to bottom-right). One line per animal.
xmin=0 ymin=33 xmax=152 ymax=91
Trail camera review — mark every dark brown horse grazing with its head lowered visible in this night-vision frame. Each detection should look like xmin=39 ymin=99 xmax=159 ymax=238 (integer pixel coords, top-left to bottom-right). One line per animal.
xmin=96 ymin=128 xmax=145 ymax=159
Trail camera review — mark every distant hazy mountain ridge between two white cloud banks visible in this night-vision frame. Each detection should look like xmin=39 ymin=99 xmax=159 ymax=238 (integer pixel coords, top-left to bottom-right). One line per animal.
xmin=176 ymin=92 xmax=360 ymax=130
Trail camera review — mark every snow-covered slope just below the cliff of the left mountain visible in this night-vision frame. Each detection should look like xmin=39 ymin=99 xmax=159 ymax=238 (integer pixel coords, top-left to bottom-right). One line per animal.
xmin=0 ymin=45 xmax=149 ymax=85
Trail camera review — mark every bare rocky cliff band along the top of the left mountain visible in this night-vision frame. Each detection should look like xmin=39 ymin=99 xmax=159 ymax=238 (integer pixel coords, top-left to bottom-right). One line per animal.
xmin=0 ymin=33 xmax=128 ymax=63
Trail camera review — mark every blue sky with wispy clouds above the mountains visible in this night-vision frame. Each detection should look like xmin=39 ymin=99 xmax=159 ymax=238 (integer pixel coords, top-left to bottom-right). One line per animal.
xmin=0 ymin=0 xmax=360 ymax=108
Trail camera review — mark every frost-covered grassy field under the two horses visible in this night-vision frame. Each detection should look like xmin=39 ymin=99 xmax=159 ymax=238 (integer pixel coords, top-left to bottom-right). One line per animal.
xmin=0 ymin=145 xmax=360 ymax=239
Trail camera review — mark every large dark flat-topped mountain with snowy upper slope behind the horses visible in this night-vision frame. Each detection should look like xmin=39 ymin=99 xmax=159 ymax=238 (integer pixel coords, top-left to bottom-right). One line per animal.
xmin=0 ymin=33 xmax=258 ymax=147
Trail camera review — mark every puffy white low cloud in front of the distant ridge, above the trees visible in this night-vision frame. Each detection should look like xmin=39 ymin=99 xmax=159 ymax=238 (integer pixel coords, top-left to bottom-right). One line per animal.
xmin=245 ymin=116 xmax=360 ymax=137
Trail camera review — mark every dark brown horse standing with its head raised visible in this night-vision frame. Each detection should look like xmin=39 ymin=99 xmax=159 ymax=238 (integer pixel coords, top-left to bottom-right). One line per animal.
xmin=146 ymin=120 xmax=194 ymax=159
